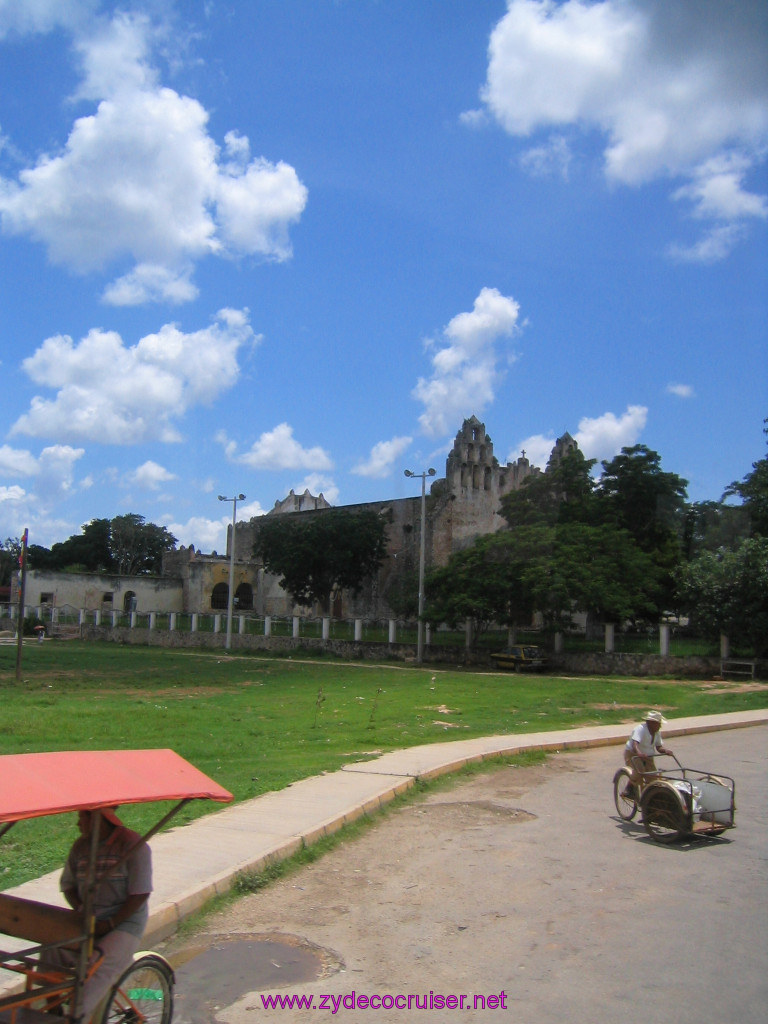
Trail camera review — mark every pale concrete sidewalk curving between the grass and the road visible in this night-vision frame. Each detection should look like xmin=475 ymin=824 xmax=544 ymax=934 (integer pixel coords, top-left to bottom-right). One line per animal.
xmin=8 ymin=710 xmax=768 ymax=946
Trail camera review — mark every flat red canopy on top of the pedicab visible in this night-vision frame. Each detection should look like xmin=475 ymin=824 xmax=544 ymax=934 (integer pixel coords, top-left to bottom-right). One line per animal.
xmin=0 ymin=750 xmax=233 ymax=822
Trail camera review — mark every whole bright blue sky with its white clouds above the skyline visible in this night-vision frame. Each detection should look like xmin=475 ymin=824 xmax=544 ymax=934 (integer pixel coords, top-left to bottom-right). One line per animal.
xmin=0 ymin=0 xmax=768 ymax=551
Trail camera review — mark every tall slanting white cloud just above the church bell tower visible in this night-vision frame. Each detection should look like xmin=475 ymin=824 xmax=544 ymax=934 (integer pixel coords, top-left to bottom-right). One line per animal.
xmin=412 ymin=288 xmax=520 ymax=437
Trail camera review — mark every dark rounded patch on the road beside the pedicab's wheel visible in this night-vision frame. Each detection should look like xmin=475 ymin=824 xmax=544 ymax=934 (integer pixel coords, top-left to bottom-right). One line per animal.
xmin=170 ymin=935 xmax=343 ymax=1024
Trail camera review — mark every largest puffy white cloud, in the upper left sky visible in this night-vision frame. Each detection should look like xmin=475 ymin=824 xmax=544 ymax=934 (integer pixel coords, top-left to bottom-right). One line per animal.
xmin=0 ymin=13 xmax=307 ymax=305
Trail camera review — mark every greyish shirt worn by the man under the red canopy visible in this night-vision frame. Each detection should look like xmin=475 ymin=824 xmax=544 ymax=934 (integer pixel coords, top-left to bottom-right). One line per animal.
xmin=60 ymin=825 xmax=152 ymax=937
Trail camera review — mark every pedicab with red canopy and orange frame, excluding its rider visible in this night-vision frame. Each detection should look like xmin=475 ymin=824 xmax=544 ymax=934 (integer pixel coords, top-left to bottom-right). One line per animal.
xmin=0 ymin=750 xmax=233 ymax=1024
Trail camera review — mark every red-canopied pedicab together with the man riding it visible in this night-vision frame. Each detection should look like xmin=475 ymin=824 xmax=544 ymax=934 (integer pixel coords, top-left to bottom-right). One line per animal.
xmin=0 ymin=750 xmax=232 ymax=1024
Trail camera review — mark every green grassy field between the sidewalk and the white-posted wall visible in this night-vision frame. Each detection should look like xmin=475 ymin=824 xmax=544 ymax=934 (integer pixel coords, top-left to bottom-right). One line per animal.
xmin=0 ymin=641 xmax=768 ymax=888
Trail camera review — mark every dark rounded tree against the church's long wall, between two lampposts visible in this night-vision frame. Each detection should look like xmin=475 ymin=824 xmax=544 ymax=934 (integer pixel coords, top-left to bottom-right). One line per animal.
xmin=253 ymin=509 xmax=387 ymax=609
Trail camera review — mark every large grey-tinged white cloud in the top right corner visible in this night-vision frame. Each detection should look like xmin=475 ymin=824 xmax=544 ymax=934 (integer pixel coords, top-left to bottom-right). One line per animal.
xmin=482 ymin=0 xmax=768 ymax=260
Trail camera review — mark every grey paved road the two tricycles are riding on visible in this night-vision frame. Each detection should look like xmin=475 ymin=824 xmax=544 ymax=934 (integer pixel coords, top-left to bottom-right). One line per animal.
xmin=165 ymin=726 xmax=768 ymax=1024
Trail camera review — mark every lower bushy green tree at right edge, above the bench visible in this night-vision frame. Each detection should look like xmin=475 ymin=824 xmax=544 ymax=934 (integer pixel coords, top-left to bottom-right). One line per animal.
xmin=678 ymin=537 xmax=768 ymax=657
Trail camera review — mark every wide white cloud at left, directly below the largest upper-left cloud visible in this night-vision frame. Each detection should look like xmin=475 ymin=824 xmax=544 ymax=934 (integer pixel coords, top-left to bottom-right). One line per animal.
xmin=11 ymin=309 xmax=253 ymax=444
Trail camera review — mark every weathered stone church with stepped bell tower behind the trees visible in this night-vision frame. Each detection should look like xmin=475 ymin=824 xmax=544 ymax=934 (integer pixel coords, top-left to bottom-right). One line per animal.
xmin=227 ymin=416 xmax=577 ymax=620
